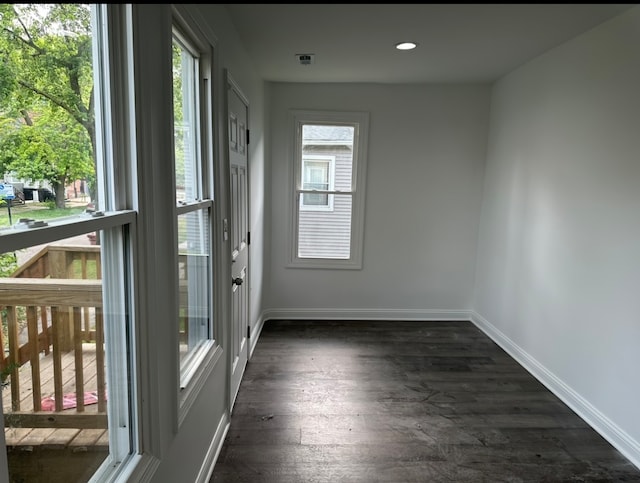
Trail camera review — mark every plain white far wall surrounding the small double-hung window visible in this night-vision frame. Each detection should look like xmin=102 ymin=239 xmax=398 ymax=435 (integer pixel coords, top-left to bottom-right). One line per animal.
xmin=265 ymin=83 xmax=490 ymax=319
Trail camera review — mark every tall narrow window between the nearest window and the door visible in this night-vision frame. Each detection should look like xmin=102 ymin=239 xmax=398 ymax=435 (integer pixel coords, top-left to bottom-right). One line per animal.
xmin=173 ymin=20 xmax=216 ymax=398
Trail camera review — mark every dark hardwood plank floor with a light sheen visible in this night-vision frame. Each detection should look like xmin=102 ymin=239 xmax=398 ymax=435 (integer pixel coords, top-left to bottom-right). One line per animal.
xmin=211 ymin=321 xmax=640 ymax=483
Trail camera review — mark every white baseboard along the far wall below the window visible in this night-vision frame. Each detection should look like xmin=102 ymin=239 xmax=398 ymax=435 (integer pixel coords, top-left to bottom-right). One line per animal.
xmin=261 ymin=309 xmax=471 ymax=321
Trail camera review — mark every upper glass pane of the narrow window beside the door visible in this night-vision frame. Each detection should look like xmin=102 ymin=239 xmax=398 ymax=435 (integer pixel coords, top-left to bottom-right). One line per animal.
xmin=173 ymin=39 xmax=200 ymax=202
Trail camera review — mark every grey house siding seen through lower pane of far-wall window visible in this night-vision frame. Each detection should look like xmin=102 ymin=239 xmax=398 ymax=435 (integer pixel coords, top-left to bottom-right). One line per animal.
xmin=298 ymin=194 xmax=352 ymax=259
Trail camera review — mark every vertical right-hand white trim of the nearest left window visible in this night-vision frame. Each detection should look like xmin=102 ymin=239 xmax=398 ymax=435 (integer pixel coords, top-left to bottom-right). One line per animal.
xmin=90 ymin=4 xmax=158 ymax=482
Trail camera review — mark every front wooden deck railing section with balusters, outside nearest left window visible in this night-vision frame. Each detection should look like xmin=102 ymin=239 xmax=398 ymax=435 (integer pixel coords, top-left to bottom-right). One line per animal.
xmin=0 ymin=278 xmax=106 ymax=428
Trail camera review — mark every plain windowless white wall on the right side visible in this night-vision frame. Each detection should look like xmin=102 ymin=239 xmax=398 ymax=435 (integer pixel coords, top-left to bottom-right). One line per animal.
xmin=474 ymin=7 xmax=640 ymax=465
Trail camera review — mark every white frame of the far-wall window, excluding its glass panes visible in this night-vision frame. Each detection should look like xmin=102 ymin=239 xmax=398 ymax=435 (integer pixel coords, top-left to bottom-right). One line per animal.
xmin=287 ymin=109 xmax=369 ymax=270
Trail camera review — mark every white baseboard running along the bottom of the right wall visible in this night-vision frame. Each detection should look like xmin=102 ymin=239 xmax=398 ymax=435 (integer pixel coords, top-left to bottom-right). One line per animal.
xmin=470 ymin=311 xmax=640 ymax=468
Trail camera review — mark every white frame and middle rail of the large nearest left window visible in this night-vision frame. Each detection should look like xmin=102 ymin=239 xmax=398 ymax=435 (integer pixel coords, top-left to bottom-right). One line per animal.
xmin=0 ymin=4 xmax=156 ymax=483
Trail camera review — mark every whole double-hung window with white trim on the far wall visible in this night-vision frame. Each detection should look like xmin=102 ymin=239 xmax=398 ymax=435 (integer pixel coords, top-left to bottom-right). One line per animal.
xmin=289 ymin=110 xmax=369 ymax=269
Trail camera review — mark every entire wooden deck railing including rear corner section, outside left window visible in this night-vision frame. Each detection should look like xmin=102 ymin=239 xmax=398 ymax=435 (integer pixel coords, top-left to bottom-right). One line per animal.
xmin=0 ymin=245 xmax=107 ymax=428
